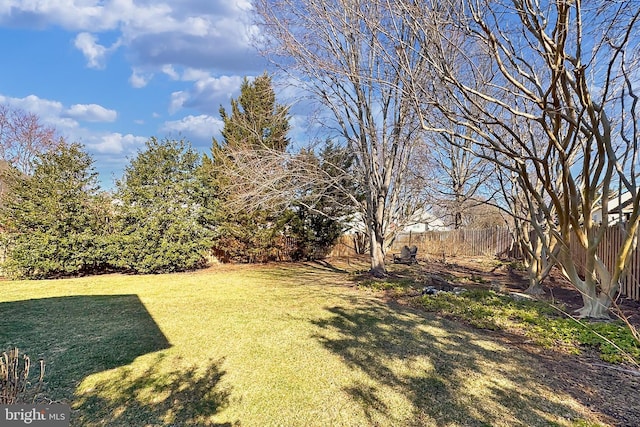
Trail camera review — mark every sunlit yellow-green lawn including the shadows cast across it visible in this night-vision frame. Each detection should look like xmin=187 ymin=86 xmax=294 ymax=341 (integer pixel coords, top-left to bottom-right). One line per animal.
xmin=0 ymin=264 xmax=598 ymax=427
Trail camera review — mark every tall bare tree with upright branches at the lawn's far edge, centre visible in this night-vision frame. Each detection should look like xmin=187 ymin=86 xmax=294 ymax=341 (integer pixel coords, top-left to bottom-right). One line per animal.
xmin=256 ymin=0 xmax=430 ymax=275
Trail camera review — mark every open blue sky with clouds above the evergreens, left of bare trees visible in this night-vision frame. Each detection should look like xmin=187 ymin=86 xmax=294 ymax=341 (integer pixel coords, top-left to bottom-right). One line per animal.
xmin=0 ymin=0 xmax=288 ymax=189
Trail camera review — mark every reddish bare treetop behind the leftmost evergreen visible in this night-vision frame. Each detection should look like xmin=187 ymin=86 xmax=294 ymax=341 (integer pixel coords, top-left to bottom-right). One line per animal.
xmin=0 ymin=105 xmax=59 ymax=174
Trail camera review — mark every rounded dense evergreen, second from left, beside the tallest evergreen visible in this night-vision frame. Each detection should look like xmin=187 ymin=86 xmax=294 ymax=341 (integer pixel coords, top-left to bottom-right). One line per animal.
xmin=115 ymin=138 xmax=211 ymax=273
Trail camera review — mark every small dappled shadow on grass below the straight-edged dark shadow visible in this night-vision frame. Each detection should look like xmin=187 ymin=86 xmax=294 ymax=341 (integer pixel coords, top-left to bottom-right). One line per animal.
xmin=72 ymin=355 xmax=237 ymax=427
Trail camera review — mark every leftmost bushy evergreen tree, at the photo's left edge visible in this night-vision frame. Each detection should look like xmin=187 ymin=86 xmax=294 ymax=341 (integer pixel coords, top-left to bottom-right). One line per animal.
xmin=0 ymin=142 xmax=110 ymax=278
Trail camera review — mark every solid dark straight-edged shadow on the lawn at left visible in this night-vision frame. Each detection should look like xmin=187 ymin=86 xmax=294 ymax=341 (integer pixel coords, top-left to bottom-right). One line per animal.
xmin=0 ymin=295 xmax=170 ymax=402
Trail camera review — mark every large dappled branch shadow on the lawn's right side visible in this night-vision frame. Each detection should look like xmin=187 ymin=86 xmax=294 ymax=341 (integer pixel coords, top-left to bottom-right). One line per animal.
xmin=313 ymin=302 xmax=604 ymax=427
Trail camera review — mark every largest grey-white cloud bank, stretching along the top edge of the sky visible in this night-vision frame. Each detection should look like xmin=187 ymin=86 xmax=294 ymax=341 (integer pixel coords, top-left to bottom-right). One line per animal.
xmin=0 ymin=0 xmax=264 ymax=73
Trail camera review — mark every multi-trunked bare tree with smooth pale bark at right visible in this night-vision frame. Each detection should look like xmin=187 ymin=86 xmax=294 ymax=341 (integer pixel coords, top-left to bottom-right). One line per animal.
xmin=394 ymin=0 xmax=640 ymax=317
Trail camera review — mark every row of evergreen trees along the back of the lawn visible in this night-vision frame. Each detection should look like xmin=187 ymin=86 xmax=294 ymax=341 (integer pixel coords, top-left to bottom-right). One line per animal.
xmin=0 ymin=74 xmax=360 ymax=278
